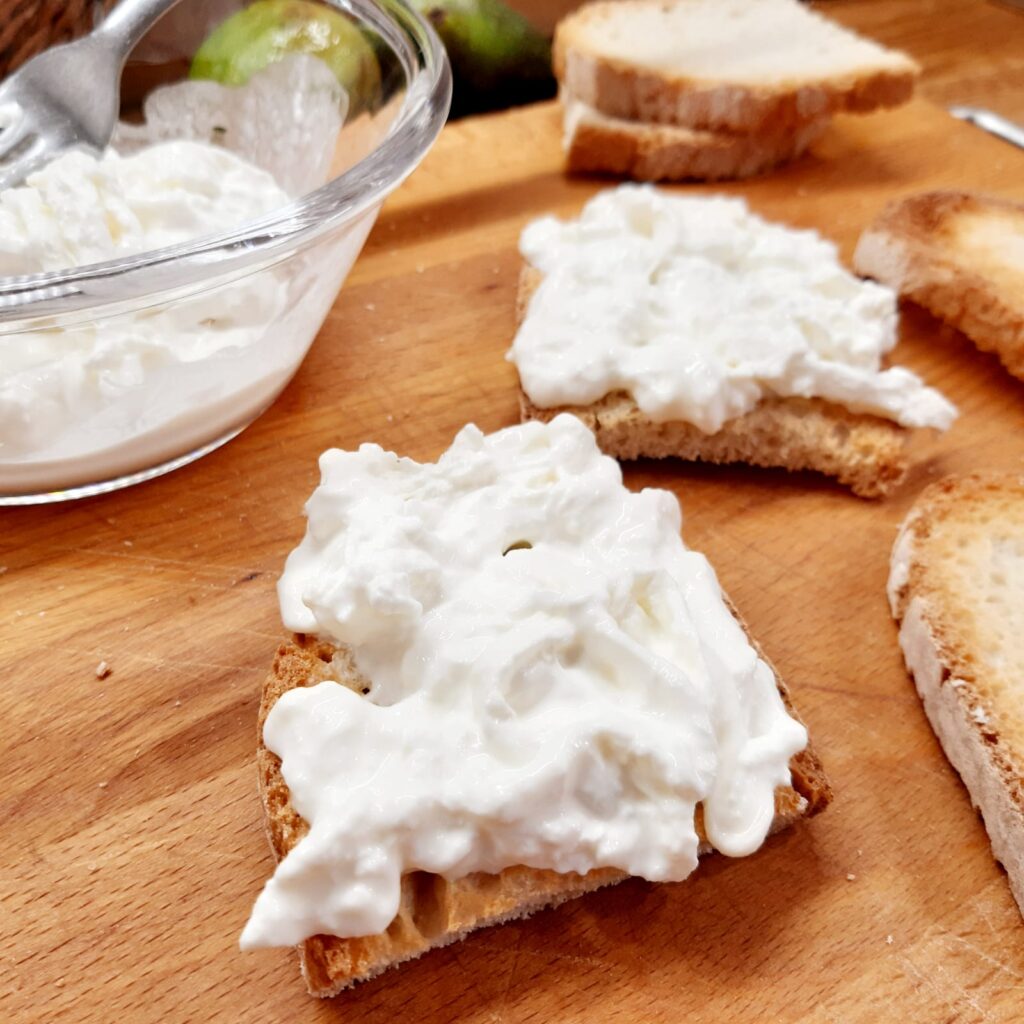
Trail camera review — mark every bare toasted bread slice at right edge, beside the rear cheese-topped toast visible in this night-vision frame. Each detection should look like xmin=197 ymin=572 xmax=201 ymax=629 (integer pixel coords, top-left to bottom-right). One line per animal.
xmin=853 ymin=191 xmax=1024 ymax=380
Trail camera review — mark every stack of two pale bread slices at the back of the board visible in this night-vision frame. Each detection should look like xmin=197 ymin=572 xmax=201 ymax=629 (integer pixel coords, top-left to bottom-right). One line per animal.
xmin=554 ymin=0 xmax=919 ymax=180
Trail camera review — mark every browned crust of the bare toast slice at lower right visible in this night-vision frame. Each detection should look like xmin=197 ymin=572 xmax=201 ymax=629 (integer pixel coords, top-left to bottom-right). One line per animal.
xmin=889 ymin=473 xmax=1024 ymax=913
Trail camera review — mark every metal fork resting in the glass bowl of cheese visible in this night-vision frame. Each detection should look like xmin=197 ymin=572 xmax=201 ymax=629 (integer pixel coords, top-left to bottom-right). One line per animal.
xmin=0 ymin=0 xmax=178 ymax=189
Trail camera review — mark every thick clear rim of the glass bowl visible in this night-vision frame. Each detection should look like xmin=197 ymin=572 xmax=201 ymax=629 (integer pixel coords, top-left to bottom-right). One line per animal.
xmin=0 ymin=0 xmax=452 ymax=323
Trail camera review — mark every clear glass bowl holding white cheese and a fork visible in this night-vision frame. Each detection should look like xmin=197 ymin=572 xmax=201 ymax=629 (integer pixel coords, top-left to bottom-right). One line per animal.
xmin=0 ymin=0 xmax=452 ymax=505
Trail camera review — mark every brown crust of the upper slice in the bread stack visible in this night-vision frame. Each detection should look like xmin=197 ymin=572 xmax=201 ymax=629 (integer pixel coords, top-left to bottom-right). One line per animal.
xmin=552 ymin=0 xmax=921 ymax=132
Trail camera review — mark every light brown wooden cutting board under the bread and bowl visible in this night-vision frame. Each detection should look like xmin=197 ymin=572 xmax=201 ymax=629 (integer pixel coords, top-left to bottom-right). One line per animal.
xmin=0 ymin=102 xmax=1024 ymax=1024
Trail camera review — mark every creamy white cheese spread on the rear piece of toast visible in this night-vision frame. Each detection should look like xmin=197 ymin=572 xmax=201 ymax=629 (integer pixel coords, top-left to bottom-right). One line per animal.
xmin=509 ymin=184 xmax=956 ymax=433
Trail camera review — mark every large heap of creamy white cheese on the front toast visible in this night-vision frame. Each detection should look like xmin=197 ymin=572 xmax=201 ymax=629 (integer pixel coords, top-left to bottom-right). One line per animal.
xmin=242 ymin=416 xmax=807 ymax=948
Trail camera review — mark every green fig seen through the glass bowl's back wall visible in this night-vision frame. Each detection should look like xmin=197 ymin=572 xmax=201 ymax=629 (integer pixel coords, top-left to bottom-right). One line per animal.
xmin=189 ymin=0 xmax=381 ymax=117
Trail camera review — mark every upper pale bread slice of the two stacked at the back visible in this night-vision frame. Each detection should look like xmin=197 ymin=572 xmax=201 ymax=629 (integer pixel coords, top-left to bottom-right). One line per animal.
xmin=553 ymin=0 xmax=920 ymax=132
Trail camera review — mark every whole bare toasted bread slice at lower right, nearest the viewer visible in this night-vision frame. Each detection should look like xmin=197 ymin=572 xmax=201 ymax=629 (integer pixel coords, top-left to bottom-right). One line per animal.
xmin=889 ymin=474 xmax=1024 ymax=912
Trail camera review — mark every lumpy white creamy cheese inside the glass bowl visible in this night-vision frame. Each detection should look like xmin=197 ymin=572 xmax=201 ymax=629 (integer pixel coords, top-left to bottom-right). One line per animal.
xmin=0 ymin=141 xmax=288 ymax=468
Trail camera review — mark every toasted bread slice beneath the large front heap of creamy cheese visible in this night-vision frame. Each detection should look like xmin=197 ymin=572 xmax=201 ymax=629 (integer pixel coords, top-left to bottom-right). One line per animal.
xmin=257 ymin=635 xmax=831 ymax=997
